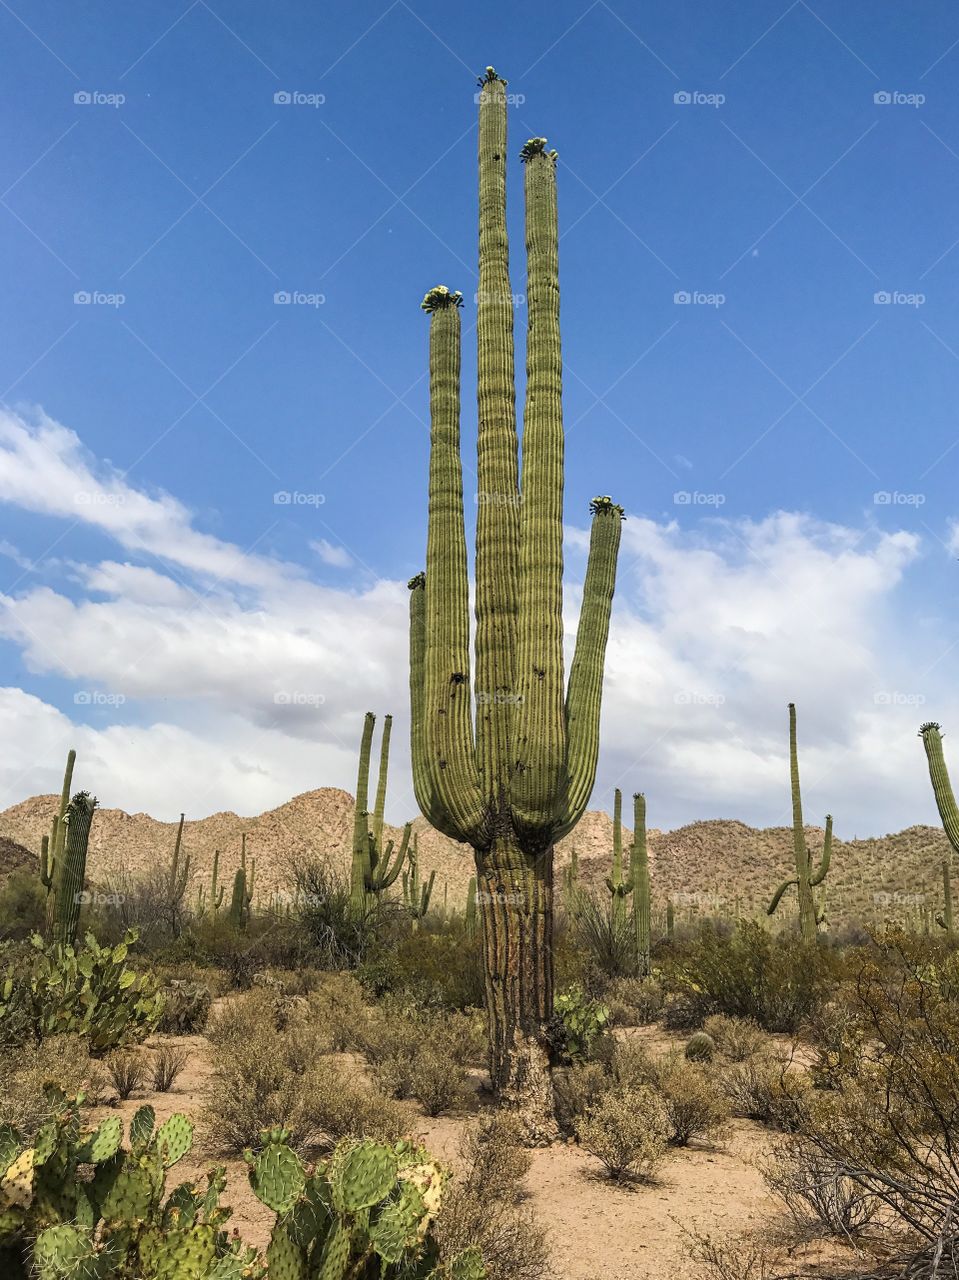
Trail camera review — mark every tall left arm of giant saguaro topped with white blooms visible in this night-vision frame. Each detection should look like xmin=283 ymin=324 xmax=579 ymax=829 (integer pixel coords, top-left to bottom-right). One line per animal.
xmin=423 ymin=285 xmax=485 ymax=844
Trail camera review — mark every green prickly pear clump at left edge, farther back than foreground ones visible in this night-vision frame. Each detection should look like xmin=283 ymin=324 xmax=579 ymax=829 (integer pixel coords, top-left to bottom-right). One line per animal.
xmin=0 ymin=933 xmax=163 ymax=1056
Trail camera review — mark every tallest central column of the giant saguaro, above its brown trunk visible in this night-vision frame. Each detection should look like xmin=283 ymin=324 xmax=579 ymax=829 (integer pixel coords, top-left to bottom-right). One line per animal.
xmin=475 ymin=73 xmax=520 ymax=809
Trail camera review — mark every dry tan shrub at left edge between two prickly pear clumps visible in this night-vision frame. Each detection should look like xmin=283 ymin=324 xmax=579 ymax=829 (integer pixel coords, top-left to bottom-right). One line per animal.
xmin=0 ymin=1036 xmax=106 ymax=1139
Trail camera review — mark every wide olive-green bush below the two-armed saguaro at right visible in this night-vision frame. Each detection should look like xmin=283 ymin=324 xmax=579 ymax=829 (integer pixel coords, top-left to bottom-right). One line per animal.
xmin=671 ymin=920 xmax=836 ymax=1032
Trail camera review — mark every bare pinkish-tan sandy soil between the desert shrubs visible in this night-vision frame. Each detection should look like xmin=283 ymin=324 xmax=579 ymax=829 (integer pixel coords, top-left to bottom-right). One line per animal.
xmin=82 ymin=1028 xmax=860 ymax=1280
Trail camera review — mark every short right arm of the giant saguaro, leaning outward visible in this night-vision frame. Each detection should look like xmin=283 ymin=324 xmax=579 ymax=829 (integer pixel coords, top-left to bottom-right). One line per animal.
xmin=557 ymin=497 xmax=624 ymax=838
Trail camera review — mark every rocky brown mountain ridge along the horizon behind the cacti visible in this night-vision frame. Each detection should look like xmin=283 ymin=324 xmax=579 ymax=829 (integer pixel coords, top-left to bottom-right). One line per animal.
xmin=0 ymin=787 xmax=950 ymax=922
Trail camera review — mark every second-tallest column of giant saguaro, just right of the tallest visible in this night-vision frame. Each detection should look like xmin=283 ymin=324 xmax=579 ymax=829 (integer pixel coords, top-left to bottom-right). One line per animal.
xmin=511 ymin=140 xmax=566 ymax=836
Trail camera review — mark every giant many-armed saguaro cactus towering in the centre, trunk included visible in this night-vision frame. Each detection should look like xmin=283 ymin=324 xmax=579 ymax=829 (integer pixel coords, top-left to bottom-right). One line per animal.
xmin=410 ymin=68 xmax=622 ymax=1142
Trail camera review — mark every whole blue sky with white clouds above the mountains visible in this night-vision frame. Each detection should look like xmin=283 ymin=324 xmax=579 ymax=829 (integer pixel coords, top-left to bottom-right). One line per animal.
xmin=0 ymin=0 xmax=959 ymax=835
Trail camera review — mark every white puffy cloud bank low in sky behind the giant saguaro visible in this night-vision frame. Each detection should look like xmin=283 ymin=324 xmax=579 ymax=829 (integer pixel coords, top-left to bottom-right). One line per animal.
xmin=0 ymin=404 xmax=959 ymax=836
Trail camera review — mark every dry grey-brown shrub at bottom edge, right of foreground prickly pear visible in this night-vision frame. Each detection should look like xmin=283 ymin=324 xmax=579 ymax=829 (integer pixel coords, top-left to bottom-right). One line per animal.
xmin=435 ymin=1112 xmax=551 ymax=1280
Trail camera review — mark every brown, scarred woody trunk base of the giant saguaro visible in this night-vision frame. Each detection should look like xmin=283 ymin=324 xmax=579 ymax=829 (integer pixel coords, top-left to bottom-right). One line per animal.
xmin=476 ymin=838 xmax=560 ymax=1147
